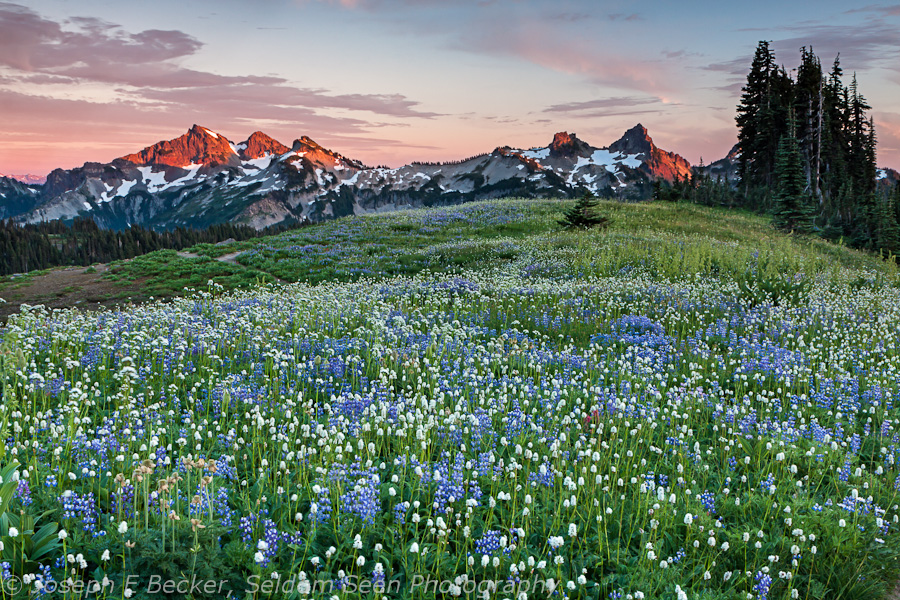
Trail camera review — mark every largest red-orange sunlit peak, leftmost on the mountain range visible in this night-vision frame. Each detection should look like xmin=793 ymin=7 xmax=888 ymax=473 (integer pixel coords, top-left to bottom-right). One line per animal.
xmin=121 ymin=124 xmax=240 ymax=167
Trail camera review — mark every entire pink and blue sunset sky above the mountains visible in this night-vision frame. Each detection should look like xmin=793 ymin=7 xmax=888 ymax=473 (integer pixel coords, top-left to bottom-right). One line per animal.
xmin=0 ymin=0 xmax=900 ymax=175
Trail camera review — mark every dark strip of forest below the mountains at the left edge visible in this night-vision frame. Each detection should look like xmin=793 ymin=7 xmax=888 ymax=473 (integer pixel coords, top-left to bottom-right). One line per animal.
xmin=0 ymin=218 xmax=305 ymax=275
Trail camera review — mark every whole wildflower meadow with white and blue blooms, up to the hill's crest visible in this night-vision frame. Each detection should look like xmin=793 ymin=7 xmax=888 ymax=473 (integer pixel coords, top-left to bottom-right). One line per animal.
xmin=0 ymin=200 xmax=900 ymax=600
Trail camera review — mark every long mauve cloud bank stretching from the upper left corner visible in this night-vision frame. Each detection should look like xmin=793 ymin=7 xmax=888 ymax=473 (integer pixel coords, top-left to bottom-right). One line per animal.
xmin=0 ymin=2 xmax=437 ymax=118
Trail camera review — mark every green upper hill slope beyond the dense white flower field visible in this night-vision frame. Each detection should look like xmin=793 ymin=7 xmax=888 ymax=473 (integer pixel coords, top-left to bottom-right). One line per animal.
xmin=107 ymin=200 xmax=897 ymax=297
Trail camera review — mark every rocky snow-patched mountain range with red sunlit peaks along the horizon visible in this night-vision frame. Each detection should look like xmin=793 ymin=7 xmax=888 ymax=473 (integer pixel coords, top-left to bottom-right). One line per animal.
xmin=0 ymin=124 xmax=896 ymax=229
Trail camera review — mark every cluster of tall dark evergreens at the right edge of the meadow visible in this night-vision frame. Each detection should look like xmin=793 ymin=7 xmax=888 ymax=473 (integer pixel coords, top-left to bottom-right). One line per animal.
xmin=654 ymin=41 xmax=900 ymax=254
